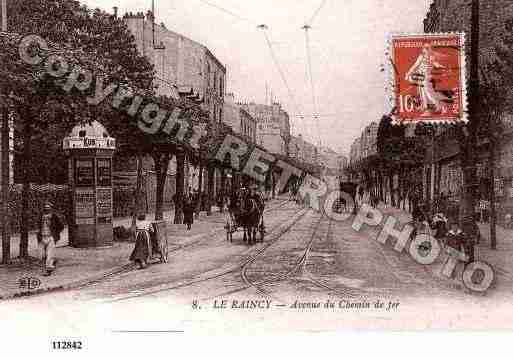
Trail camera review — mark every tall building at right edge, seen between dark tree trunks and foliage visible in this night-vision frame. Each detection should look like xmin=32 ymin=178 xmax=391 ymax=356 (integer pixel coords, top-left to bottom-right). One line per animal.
xmin=424 ymin=0 xmax=513 ymax=225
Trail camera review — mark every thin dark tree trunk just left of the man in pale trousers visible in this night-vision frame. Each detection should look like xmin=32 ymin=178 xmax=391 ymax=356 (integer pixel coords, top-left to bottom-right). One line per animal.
xmin=20 ymin=118 xmax=32 ymax=258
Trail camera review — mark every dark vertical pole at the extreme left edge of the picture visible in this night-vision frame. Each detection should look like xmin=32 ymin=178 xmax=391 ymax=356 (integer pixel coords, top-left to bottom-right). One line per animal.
xmin=0 ymin=0 xmax=11 ymax=264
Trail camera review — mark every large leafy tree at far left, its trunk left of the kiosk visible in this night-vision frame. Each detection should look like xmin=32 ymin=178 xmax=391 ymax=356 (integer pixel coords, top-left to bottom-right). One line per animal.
xmin=2 ymin=0 xmax=153 ymax=257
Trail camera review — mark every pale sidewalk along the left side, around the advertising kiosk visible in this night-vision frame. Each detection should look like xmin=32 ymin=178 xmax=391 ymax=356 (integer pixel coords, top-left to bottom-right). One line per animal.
xmin=0 ymin=207 xmax=225 ymax=300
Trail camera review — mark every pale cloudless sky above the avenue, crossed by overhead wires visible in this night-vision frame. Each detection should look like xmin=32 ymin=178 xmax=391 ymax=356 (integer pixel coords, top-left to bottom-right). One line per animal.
xmin=80 ymin=0 xmax=431 ymax=155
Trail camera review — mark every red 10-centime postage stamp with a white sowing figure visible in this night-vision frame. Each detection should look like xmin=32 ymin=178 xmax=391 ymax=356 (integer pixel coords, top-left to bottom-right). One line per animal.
xmin=390 ymin=34 xmax=466 ymax=123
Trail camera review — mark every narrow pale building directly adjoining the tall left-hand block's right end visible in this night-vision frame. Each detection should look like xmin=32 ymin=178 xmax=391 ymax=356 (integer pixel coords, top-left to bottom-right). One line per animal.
xmin=223 ymin=93 xmax=257 ymax=143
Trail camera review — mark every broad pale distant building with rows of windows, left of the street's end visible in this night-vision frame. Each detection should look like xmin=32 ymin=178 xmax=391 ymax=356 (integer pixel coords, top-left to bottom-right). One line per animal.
xmin=240 ymin=102 xmax=290 ymax=155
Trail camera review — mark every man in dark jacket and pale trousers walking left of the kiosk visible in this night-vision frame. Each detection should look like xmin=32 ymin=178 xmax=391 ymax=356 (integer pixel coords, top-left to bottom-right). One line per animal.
xmin=37 ymin=202 xmax=64 ymax=276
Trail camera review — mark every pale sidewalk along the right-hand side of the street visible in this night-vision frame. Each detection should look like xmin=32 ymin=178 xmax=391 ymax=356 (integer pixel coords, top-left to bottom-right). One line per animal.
xmin=379 ymin=204 xmax=513 ymax=287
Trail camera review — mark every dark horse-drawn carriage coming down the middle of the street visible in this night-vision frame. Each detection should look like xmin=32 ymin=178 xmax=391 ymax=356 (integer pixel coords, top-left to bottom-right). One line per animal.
xmin=225 ymin=189 xmax=265 ymax=244
